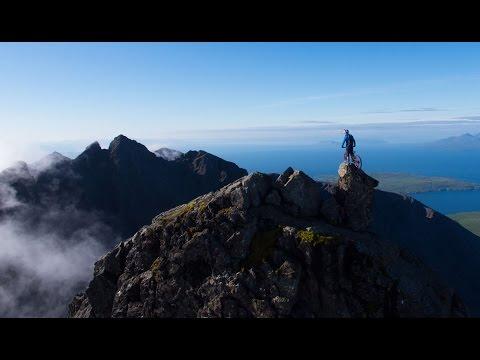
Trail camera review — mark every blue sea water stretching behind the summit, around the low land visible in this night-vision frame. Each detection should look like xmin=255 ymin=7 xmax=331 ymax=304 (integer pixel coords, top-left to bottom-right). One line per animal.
xmin=211 ymin=145 xmax=480 ymax=214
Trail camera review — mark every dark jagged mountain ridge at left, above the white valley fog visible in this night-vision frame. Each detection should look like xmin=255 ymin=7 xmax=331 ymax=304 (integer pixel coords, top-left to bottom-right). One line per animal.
xmin=0 ymin=135 xmax=247 ymax=242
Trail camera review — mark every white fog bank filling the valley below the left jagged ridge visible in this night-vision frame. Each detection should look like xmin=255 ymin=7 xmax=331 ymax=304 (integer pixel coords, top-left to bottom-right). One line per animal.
xmin=0 ymin=167 xmax=118 ymax=317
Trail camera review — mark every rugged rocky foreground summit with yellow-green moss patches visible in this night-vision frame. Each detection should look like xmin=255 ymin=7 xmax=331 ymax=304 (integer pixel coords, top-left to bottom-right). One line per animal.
xmin=69 ymin=169 xmax=466 ymax=318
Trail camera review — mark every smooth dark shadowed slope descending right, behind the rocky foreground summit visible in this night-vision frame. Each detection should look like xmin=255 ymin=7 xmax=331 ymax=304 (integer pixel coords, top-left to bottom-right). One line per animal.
xmin=369 ymin=190 xmax=480 ymax=316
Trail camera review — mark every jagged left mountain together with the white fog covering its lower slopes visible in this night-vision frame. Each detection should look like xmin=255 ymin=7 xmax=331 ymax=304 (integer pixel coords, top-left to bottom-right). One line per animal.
xmin=0 ymin=136 xmax=246 ymax=317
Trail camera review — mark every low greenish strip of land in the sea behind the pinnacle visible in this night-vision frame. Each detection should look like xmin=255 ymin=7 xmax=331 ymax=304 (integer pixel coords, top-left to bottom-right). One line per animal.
xmin=316 ymin=173 xmax=480 ymax=194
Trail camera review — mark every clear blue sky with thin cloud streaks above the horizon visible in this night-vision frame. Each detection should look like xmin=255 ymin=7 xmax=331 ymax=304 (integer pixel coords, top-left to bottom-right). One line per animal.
xmin=0 ymin=43 xmax=480 ymax=162
